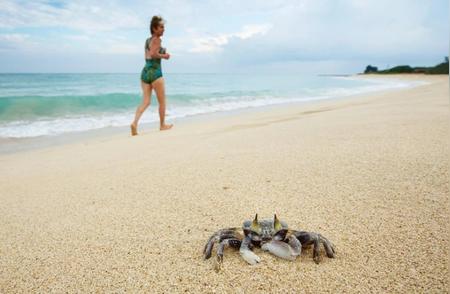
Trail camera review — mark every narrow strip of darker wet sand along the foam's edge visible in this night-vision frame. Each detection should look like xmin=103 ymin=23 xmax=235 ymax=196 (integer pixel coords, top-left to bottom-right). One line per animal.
xmin=0 ymin=74 xmax=433 ymax=156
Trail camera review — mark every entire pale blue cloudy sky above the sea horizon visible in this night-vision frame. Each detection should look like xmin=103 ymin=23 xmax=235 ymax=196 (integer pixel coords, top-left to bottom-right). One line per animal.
xmin=0 ymin=0 xmax=449 ymax=74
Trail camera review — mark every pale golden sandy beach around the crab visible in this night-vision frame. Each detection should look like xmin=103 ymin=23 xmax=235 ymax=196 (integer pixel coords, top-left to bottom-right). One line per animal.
xmin=0 ymin=76 xmax=450 ymax=293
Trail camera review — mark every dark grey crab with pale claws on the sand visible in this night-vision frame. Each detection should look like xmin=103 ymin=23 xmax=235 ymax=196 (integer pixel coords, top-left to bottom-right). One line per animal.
xmin=203 ymin=214 xmax=335 ymax=270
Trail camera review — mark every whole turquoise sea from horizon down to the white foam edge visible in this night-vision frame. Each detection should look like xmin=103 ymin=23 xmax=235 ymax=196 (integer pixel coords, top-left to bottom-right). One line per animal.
xmin=0 ymin=73 xmax=413 ymax=138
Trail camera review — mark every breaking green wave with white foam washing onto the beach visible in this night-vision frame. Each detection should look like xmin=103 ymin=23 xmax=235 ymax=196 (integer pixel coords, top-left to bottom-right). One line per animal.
xmin=0 ymin=77 xmax=423 ymax=138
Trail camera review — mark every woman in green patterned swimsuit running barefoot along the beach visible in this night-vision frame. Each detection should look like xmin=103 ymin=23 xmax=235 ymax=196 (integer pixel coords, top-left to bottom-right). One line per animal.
xmin=131 ymin=16 xmax=173 ymax=136
